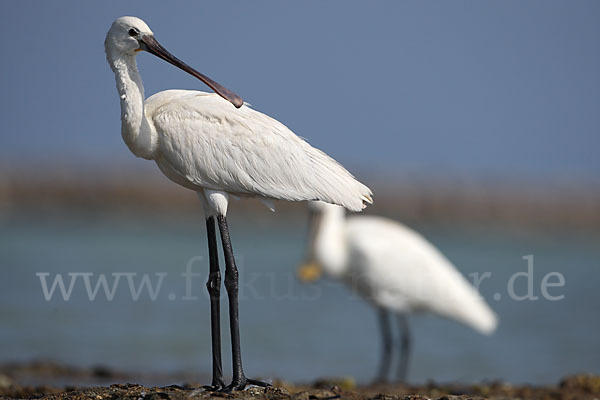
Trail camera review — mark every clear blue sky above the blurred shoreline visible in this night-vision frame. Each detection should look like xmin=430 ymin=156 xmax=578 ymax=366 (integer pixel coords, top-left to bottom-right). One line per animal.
xmin=0 ymin=0 xmax=600 ymax=179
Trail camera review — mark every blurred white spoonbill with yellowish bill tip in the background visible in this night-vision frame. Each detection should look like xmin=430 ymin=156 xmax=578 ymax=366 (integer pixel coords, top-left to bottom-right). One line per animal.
xmin=298 ymin=202 xmax=497 ymax=381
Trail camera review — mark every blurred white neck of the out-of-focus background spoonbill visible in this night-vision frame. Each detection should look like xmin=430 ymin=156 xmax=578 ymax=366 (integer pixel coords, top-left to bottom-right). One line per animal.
xmin=315 ymin=205 xmax=348 ymax=278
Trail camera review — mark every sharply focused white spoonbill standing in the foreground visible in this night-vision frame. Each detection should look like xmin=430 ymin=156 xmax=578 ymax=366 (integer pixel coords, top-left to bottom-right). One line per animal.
xmin=104 ymin=17 xmax=372 ymax=390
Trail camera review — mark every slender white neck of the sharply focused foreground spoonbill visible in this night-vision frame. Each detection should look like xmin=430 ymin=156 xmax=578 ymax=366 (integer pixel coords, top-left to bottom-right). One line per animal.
xmin=108 ymin=54 xmax=156 ymax=159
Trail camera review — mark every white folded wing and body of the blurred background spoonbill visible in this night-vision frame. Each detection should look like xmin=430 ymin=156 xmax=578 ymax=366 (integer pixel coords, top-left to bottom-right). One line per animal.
xmin=347 ymin=216 xmax=497 ymax=333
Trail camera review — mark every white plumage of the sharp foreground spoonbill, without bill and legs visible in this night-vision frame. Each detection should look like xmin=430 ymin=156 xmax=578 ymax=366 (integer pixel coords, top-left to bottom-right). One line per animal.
xmin=105 ymin=17 xmax=372 ymax=216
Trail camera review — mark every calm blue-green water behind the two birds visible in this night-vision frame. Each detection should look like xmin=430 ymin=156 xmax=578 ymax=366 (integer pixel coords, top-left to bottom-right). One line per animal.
xmin=0 ymin=215 xmax=600 ymax=383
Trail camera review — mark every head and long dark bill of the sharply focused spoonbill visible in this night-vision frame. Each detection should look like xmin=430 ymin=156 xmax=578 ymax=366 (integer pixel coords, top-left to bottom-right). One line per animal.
xmin=104 ymin=17 xmax=244 ymax=108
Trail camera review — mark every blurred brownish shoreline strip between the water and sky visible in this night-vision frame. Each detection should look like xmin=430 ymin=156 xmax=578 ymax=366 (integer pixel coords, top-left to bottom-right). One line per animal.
xmin=0 ymin=162 xmax=600 ymax=230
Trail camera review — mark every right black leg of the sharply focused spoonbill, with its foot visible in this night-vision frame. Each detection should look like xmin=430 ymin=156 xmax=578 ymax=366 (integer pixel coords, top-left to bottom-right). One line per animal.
xmin=217 ymin=215 xmax=269 ymax=391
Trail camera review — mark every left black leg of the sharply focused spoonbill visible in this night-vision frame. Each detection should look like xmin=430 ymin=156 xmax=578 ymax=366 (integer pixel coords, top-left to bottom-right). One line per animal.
xmin=206 ymin=216 xmax=225 ymax=390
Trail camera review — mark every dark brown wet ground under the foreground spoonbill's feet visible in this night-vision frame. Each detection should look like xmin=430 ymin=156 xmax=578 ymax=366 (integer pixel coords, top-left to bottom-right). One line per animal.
xmin=0 ymin=363 xmax=600 ymax=400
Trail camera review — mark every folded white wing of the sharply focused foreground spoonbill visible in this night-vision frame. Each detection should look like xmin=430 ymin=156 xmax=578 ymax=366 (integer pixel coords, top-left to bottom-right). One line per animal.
xmin=146 ymin=91 xmax=372 ymax=211
